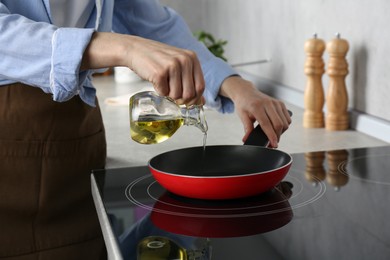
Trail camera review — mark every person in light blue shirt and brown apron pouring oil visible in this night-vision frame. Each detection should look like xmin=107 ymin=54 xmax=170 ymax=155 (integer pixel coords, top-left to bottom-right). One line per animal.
xmin=0 ymin=0 xmax=290 ymax=259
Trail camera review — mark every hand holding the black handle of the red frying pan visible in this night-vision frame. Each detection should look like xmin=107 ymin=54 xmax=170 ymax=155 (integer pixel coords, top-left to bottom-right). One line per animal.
xmin=220 ymin=76 xmax=291 ymax=148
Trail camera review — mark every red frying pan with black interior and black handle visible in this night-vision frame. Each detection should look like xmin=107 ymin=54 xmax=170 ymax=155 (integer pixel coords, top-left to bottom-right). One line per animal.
xmin=149 ymin=111 xmax=292 ymax=200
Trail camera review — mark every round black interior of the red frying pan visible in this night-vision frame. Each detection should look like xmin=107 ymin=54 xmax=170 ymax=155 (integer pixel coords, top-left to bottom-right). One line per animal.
xmin=149 ymin=145 xmax=292 ymax=177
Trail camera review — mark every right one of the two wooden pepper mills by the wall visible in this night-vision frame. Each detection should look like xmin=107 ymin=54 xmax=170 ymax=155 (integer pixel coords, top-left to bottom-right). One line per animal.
xmin=325 ymin=33 xmax=349 ymax=130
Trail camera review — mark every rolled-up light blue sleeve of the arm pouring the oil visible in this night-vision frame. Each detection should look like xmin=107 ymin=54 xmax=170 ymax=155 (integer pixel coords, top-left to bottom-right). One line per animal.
xmin=0 ymin=3 xmax=96 ymax=106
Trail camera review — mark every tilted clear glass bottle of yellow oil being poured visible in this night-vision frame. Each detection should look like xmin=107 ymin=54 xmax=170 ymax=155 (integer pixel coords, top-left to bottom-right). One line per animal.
xmin=130 ymin=91 xmax=208 ymax=144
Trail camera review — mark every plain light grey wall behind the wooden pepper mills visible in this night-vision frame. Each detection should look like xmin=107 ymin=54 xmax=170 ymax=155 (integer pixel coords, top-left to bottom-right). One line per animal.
xmin=162 ymin=0 xmax=390 ymax=121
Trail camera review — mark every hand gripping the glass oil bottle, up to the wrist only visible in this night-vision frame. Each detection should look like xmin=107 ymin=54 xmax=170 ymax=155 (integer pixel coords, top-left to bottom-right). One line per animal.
xmin=128 ymin=38 xmax=205 ymax=105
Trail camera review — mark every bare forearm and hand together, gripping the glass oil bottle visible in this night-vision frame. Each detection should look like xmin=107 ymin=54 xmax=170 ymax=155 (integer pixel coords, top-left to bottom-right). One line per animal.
xmin=81 ymin=32 xmax=205 ymax=105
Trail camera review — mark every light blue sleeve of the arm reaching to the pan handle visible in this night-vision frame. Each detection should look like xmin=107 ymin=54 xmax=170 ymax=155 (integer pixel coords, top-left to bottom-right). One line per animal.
xmin=113 ymin=0 xmax=237 ymax=113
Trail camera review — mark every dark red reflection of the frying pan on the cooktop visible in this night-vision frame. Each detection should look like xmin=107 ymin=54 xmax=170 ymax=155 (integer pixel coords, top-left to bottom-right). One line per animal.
xmin=151 ymin=182 xmax=293 ymax=238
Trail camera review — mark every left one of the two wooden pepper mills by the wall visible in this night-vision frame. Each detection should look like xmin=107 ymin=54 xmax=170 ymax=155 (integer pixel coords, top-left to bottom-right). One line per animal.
xmin=303 ymin=34 xmax=325 ymax=128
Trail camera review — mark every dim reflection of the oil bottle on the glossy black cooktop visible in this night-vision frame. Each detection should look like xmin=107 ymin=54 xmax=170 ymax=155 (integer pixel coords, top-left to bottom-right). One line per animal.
xmin=137 ymin=236 xmax=210 ymax=260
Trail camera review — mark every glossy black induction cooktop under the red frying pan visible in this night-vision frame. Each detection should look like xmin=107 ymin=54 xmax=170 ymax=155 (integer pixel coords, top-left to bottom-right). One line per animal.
xmin=92 ymin=146 xmax=390 ymax=260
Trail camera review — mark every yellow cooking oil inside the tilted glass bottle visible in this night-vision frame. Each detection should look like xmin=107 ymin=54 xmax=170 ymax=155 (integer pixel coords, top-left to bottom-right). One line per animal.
xmin=130 ymin=116 xmax=184 ymax=144
